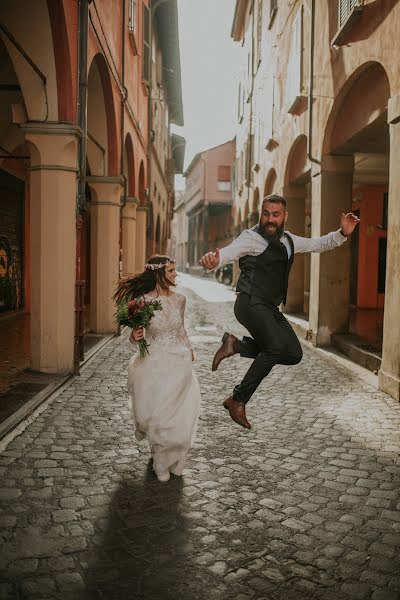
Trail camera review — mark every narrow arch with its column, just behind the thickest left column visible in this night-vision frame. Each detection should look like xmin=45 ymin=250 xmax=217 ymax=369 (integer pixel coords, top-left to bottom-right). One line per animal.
xmin=87 ymin=53 xmax=123 ymax=333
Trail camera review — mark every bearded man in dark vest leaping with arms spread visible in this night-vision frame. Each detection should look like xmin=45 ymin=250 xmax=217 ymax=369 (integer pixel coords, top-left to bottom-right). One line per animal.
xmin=200 ymin=194 xmax=359 ymax=429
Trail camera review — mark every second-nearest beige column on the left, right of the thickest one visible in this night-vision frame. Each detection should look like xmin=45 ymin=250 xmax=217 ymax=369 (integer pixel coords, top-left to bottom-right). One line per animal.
xmin=87 ymin=177 xmax=123 ymax=333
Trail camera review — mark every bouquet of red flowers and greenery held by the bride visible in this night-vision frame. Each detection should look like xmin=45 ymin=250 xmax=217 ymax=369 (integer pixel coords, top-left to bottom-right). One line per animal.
xmin=115 ymin=298 xmax=162 ymax=358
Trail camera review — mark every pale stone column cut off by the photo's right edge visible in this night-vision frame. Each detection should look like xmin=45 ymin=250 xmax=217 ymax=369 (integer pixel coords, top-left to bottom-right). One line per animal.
xmin=379 ymin=94 xmax=400 ymax=400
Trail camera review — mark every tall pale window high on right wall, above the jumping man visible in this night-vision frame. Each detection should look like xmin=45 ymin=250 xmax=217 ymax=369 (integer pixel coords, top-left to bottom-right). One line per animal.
xmin=286 ymin=7 xmax=303 ymax=112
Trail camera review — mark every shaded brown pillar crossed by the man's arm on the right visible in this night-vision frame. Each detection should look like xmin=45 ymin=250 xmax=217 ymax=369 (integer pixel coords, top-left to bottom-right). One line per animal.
xmin=283 ymin=185 xmax=305 ymax=314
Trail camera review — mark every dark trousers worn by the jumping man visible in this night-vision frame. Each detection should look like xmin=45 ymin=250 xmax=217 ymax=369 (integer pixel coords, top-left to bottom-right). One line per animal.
xmin=233 ymin=293 xmax=303 ymax=404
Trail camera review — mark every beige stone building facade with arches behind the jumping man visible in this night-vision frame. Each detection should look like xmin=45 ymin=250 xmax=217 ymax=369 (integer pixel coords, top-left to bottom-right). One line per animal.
xmin=232 ymin=0 xmax=400 ymax=398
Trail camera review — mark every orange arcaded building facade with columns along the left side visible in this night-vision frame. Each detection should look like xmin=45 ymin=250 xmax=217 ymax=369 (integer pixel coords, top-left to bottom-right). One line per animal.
xmin=0 ymin=0 xmax=182 ymax=380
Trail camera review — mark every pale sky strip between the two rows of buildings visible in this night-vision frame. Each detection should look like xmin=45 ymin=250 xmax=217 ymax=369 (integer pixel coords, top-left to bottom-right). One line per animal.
xmin=174 ymin=0 xmax=240 ymax=189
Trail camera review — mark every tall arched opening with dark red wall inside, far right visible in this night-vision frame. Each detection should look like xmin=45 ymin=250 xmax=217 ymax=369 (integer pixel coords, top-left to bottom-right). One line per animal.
xmin=321 ymin=62 xmax=390 ymax=360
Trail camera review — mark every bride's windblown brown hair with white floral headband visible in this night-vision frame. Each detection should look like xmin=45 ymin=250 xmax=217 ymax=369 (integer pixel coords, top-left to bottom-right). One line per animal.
xmin=113 ymin=254 xmax=175 ymax=304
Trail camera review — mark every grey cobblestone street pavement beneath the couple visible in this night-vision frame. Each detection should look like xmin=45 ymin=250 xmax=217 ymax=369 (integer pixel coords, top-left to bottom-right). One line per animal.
xmin=0 ymin=282 xmax=400 ymax=600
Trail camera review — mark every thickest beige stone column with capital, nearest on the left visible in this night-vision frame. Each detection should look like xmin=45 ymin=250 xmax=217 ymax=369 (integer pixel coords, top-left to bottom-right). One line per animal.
xmin=21 ymin=123 xmax=81 ymax=373
